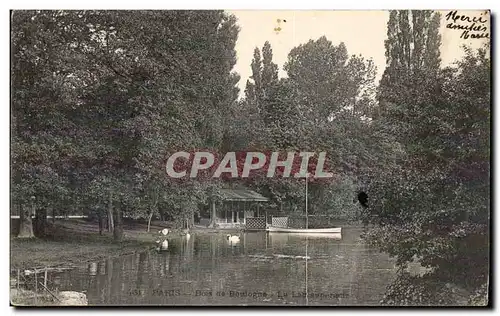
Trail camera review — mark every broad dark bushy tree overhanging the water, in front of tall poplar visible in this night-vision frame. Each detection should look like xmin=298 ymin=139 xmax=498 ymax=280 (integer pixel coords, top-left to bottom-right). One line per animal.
xmin=364 ymin=36 xmax=490 ymax=305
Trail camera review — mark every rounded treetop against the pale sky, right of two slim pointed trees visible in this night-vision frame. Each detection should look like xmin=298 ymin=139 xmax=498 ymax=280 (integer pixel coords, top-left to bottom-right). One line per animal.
xmin=284 ymin=36 xmax=375 ymax=124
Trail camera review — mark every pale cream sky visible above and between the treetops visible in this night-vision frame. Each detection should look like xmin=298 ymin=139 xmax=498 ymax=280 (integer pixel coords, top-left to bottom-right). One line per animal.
xmin=228 ymin=10 xmax=489 ymax=96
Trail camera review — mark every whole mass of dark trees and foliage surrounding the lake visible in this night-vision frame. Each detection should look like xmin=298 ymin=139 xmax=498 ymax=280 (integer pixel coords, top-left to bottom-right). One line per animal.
xmin=11 ymin=11 xmax=491 ymax=305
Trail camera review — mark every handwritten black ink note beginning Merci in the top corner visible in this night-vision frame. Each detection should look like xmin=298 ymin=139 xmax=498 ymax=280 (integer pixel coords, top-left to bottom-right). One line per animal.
xmin=445 ymin=10 xmax=490 ymax=39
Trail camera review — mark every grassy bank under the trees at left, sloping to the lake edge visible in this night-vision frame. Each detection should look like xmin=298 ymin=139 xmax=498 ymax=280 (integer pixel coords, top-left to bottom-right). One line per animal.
xmin=10 ymin=220 xmax=170 ymax=270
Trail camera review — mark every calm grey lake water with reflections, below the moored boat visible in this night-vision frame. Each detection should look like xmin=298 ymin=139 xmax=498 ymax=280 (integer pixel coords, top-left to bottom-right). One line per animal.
xmin=47 ymin=228 xmax=395 ymax=305
